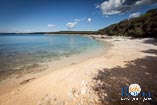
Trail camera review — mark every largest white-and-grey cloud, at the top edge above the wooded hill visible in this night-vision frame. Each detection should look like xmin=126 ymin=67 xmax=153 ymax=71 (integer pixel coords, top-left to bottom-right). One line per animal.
xmin=96 ymin=0 xmax=157 ymax=15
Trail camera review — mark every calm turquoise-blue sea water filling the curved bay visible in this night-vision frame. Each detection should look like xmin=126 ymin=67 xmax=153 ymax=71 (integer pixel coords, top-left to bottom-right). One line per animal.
xmin=0 ymin=34 xmax=104 ymax=79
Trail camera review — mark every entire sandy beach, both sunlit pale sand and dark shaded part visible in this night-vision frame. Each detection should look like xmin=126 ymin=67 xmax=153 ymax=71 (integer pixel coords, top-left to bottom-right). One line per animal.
xmin=0 ymin=35 xmax=157 ymax=105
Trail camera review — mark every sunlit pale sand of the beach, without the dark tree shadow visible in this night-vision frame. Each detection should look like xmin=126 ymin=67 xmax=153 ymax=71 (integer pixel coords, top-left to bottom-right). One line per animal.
xmin=0 ymin=35 xmax=157 ymax=105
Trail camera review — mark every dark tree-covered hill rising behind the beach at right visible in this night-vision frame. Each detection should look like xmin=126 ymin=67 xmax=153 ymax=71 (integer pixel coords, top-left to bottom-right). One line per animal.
xmin=97 ymin=9 xmax=157 ymax=37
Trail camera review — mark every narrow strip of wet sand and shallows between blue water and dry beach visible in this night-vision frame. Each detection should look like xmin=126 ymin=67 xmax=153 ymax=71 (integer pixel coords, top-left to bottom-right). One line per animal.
xmin=0 ymin=35 xmax=111 ymax=95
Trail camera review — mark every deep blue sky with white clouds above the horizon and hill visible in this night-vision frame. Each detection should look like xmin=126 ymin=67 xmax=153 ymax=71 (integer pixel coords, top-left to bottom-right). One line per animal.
xmin=0 ymin=0 xmax=157 ymax=32
